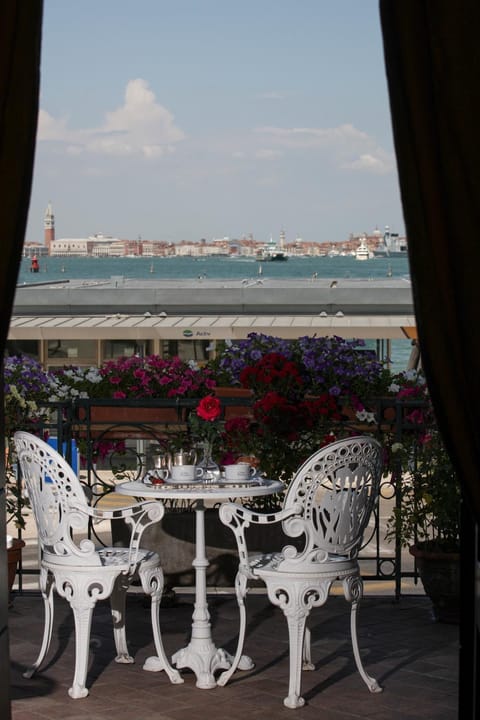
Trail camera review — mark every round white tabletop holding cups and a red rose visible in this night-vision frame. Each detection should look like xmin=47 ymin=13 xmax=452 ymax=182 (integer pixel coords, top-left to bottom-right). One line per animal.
xmin=115 ymin=477 xmax=285 ymax=500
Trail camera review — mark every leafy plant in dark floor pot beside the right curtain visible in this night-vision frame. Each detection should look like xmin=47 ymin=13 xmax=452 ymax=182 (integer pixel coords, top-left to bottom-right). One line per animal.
xmin=387 ymin=381 xmax=461 ymax=622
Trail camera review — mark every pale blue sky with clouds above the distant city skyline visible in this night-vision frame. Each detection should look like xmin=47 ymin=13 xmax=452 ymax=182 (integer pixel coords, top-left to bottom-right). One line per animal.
xmin=26 ymin=0 xmax=404 ymax=242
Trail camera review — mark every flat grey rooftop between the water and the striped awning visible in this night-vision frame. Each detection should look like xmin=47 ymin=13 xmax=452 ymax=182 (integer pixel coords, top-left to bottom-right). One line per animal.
xmin=13 ymin=275 xmax=413 ymax=316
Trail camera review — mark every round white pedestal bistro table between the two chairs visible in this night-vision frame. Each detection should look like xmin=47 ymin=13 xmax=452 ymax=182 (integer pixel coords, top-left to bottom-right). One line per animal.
xmin=115 ymin=477 xmax=285 ymax=690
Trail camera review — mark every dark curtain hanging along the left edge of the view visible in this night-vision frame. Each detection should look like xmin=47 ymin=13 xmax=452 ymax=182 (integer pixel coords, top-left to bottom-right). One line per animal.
xmin=0 ymin=0 xmax=43 ymax=720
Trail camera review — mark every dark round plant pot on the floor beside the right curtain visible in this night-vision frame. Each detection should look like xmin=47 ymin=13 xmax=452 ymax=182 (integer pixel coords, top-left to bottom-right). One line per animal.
xmin=409 ymin=545 xmax=460 ymax=624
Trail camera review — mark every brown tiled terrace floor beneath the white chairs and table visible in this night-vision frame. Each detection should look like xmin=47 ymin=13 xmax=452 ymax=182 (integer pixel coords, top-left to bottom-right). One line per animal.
xmin=9 ymin=594 xmax=458 ymax=720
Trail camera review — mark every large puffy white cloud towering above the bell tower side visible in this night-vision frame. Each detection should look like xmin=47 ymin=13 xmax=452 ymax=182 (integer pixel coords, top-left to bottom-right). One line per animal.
xmin=37 ymin=78 xmax=185 ymax=159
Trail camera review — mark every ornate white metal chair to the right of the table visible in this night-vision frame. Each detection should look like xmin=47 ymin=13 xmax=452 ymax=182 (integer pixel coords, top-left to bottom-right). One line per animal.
xmin=218 ymin=436 xmax=382 ymax=708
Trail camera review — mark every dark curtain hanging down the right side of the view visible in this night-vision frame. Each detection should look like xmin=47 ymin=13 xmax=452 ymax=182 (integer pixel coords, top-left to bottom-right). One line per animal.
xmin=380 ymin=0 xmax=480 ymax=718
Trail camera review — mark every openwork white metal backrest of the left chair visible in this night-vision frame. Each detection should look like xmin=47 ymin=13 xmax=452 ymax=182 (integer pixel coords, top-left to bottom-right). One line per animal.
xmin=14 ymin=431 xmax=101 ymax=565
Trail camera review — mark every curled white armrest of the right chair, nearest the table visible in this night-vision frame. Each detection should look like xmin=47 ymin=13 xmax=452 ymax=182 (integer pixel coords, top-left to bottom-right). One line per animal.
xmin=219 ymin=503 xmax=302 ymax=578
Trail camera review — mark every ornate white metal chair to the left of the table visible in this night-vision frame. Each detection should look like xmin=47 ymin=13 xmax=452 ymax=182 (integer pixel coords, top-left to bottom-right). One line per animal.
xmin=14 ymin=431 xmax=183 ymax=698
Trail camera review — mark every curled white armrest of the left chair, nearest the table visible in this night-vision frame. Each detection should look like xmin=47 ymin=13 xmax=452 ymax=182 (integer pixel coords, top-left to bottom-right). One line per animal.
xmin=70 ymin=500 xmax=165 ymax=574
